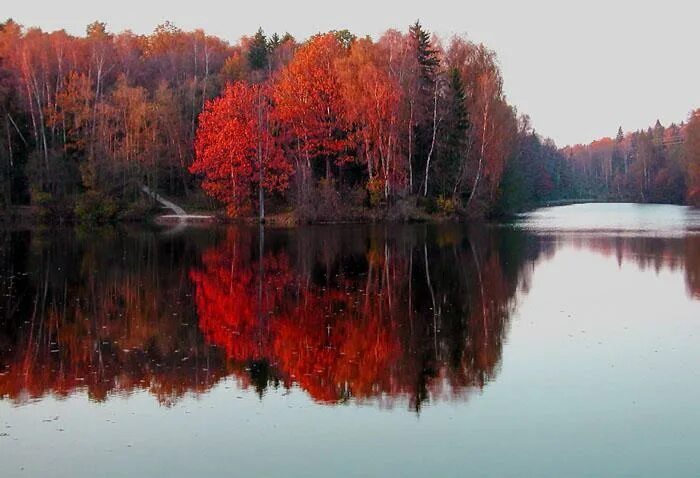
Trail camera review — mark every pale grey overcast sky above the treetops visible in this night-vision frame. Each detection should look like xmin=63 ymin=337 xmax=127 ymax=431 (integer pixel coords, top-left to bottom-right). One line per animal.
xmin=6 ymin=0 xmax=700 ymax=146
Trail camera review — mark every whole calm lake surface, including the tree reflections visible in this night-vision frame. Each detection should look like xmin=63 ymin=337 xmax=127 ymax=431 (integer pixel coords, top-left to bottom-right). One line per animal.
xmin=0 ymin=205 xmax=700 ymax=477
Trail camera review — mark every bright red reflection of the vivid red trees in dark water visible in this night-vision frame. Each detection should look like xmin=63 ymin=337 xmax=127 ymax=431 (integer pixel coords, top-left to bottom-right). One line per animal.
xmin=191 ymin=235 xmax=400 ymax=402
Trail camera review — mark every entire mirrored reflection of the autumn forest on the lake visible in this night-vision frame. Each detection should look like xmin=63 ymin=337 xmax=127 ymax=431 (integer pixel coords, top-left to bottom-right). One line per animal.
xmin=0 ymin=226 xmax=700 ymax=409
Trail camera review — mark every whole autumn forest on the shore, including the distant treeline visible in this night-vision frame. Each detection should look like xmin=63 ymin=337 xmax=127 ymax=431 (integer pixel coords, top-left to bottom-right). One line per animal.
xmin=0 ymin=16 xmax=700 ymax=222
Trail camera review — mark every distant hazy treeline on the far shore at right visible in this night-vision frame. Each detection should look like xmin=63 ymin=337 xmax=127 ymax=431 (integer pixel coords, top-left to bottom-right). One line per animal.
xmin=501 ymin=110 xmax=700 ymax=211
